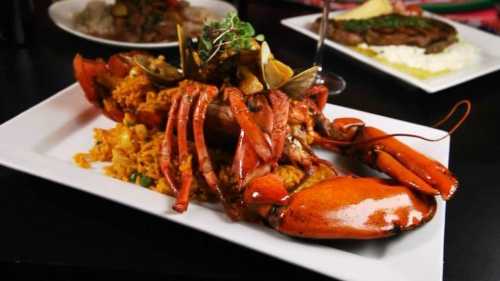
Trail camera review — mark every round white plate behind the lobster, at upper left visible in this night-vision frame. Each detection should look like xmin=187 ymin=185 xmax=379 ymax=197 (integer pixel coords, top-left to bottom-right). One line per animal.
xmin=49 ymin=0 xmax=236 ymax=49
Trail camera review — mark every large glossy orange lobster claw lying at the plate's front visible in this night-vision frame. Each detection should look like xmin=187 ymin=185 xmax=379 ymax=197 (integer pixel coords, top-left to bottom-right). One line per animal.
xmin=268 ymin=176 xmax=436 ymax=239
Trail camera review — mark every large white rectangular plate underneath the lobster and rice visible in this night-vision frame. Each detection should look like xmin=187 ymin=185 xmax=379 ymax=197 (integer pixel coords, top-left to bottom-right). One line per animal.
xmin=0 ymin=84 xmax=449 ymax=281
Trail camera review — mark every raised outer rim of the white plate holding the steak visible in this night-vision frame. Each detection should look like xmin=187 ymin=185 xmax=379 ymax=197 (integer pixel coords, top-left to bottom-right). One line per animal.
xmin=281 ymin=11 xmax=500 ymax=94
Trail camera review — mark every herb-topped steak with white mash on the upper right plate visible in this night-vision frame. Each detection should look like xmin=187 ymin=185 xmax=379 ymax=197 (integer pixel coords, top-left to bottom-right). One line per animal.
xmin=312 ymin=0 xmax=479 ymax=79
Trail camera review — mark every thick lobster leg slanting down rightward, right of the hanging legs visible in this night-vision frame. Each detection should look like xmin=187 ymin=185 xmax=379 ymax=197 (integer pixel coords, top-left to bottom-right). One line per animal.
xmin=224 ymin=87 xmax=273 ymax=162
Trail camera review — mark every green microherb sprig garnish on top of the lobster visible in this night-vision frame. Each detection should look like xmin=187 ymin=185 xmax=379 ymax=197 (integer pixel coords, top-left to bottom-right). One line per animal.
xmin=198 ymin=12 xmax=264 ymax=63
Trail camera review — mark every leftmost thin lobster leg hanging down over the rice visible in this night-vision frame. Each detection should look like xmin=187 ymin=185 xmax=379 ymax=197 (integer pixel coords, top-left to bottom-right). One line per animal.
xmin=160 ymin=90 xmax=181 ymax=194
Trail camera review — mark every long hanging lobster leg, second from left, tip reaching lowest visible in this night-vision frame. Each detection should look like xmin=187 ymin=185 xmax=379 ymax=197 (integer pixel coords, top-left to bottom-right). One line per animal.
xmin=173 ymin=81 xmax=200 ymax=213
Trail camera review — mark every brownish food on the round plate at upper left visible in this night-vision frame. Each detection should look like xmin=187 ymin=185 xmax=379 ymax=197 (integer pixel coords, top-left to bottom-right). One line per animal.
xmin=73 ymin=0 xmax=216 ymax=43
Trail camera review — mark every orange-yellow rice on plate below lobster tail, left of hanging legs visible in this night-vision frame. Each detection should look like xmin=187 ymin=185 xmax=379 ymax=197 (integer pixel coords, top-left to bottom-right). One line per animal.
xmin=73 ymin=111 xmax=207 ymax=200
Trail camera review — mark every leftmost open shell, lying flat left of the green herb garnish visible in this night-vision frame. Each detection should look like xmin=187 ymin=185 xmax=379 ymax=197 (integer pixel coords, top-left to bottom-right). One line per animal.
xmin=132 ymin=54 xmax=184 ymax=86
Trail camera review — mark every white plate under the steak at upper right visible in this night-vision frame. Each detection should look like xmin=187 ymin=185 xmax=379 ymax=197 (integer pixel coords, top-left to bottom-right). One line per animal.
xmin=281 ymin=12 xmax=500 ymax=93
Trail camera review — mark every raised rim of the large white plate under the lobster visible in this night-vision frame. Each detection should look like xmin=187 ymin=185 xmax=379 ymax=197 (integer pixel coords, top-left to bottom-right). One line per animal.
xmin=0 ymin=83 xmax=450 ymax=281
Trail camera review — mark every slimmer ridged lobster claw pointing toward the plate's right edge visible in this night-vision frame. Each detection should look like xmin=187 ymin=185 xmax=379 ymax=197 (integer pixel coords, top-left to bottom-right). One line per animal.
xmin=346 ymin=126 xmax=458 ymax=200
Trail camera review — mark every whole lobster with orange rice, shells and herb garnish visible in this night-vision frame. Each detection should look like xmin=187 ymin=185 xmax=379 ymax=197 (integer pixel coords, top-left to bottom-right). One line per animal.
xmin=73 ymin=14 xmax=458 ymax=239
